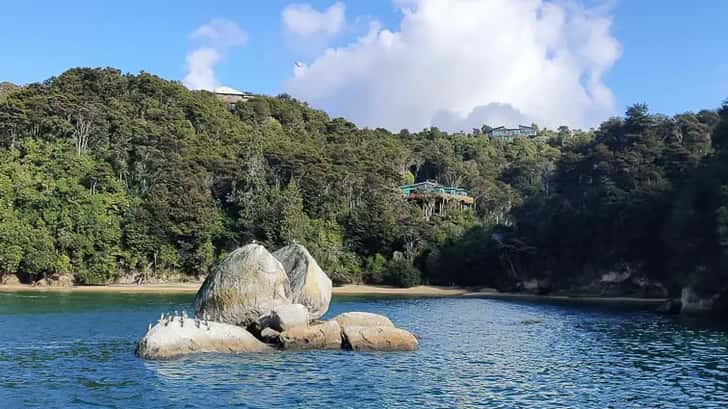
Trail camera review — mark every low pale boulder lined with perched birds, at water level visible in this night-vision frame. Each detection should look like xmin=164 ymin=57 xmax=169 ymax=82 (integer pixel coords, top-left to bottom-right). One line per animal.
xmin=136 ymin=317 xmax=272 ymax=359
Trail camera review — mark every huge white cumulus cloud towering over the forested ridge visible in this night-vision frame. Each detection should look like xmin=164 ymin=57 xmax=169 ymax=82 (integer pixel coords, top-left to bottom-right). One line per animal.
xmin=285 ymin=0 xmax=621 ymax=130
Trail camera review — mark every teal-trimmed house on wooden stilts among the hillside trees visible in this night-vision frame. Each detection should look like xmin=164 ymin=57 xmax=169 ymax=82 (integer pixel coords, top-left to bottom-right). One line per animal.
xmin=400 ymin=180 xmax=475 ymax=220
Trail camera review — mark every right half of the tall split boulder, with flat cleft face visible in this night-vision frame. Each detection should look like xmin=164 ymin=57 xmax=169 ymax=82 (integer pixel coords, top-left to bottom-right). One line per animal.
xmin=273 ymin=244 xmax=331 ymax=319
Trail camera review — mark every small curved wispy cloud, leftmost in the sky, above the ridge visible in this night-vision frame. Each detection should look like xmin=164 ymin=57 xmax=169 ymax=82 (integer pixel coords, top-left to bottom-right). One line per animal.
xmin=182 ymin=19 xmax=248 ymax=90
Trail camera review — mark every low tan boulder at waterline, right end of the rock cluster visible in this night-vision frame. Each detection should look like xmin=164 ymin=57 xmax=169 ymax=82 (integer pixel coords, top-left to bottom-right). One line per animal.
xmin=343 ymin=326 xmax=419 ymax=351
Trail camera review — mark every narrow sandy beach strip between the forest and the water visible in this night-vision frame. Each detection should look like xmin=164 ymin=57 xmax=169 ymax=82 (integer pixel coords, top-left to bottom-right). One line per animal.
xmin=0 ymin=282 xmax=667 ymax=306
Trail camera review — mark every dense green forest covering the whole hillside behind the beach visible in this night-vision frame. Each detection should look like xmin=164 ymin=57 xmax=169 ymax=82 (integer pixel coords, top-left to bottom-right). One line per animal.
xmin=0 ymin=69 xmax=728 ymax=302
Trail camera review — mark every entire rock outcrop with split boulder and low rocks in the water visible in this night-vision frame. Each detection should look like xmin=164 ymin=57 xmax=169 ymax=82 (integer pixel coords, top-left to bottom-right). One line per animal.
xmin=136 ymin=244 xmax=419 ymax=359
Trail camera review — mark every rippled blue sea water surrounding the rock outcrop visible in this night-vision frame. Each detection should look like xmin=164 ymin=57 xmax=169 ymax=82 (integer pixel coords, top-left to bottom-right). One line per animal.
xmin=0 ymin=293 xmax=728 ymax=408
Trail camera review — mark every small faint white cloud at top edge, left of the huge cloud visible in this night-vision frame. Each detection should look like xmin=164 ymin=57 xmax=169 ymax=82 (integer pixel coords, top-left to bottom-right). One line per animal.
xmin=282 ymin=2 xmax=346 ymax=38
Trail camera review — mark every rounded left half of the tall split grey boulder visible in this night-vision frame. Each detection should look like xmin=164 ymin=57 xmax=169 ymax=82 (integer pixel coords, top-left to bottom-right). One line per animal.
xmin=194 ymin=244 xmax=290 ymax=327
